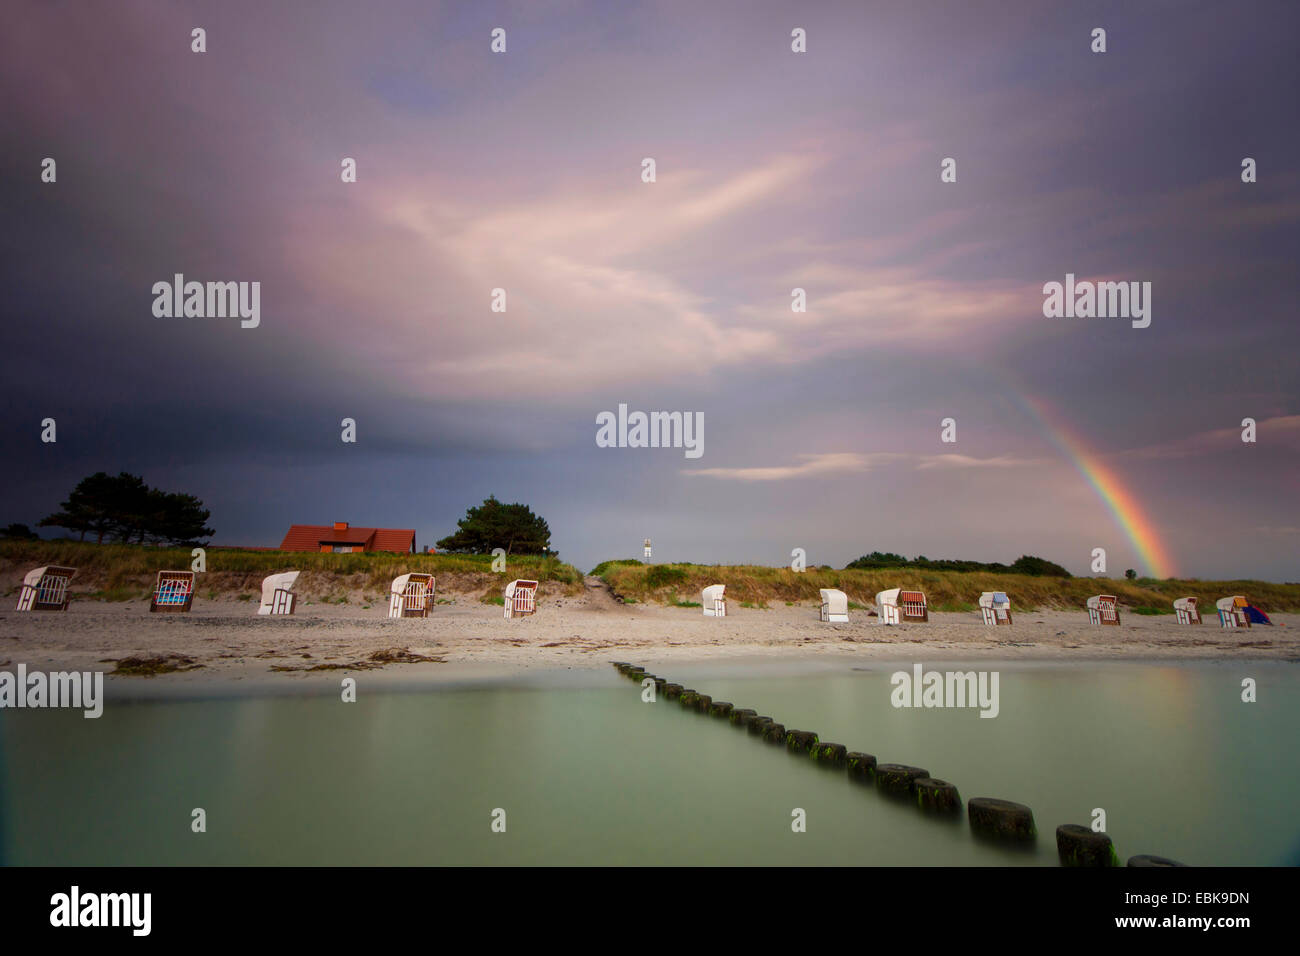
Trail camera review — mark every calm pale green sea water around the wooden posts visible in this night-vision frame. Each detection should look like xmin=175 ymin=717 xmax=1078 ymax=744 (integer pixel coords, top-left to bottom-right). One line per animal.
xmin=0 ymin=663 xmax=1300 ymax=865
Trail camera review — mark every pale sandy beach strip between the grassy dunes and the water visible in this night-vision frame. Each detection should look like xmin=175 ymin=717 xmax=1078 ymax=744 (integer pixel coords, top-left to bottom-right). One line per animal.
xmin=0 ymin=579 xmax=1300 ymax=684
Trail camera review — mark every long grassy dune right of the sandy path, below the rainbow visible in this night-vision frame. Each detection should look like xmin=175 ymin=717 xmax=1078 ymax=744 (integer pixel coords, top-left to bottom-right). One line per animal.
xmin=594 ymin=562 xmax=1300 ymax=614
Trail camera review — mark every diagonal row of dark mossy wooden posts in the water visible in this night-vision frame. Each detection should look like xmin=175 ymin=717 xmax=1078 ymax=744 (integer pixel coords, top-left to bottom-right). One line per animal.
xmin=612 ymin=661 xmax=1184 ymax=866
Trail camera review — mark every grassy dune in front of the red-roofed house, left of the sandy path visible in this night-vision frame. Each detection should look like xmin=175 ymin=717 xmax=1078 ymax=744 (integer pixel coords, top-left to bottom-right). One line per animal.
xmin=0 ymin=541 xmax=582 ymax=604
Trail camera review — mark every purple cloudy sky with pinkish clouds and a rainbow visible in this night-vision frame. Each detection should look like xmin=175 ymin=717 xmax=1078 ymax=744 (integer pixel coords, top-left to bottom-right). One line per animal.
xmin=0 ymin=0 xmax=1300 ymax=581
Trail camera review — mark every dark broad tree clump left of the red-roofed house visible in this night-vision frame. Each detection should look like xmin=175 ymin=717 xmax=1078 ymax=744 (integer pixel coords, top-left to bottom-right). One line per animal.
xmin=39 ymin=471 xmax=213 ymax=545
